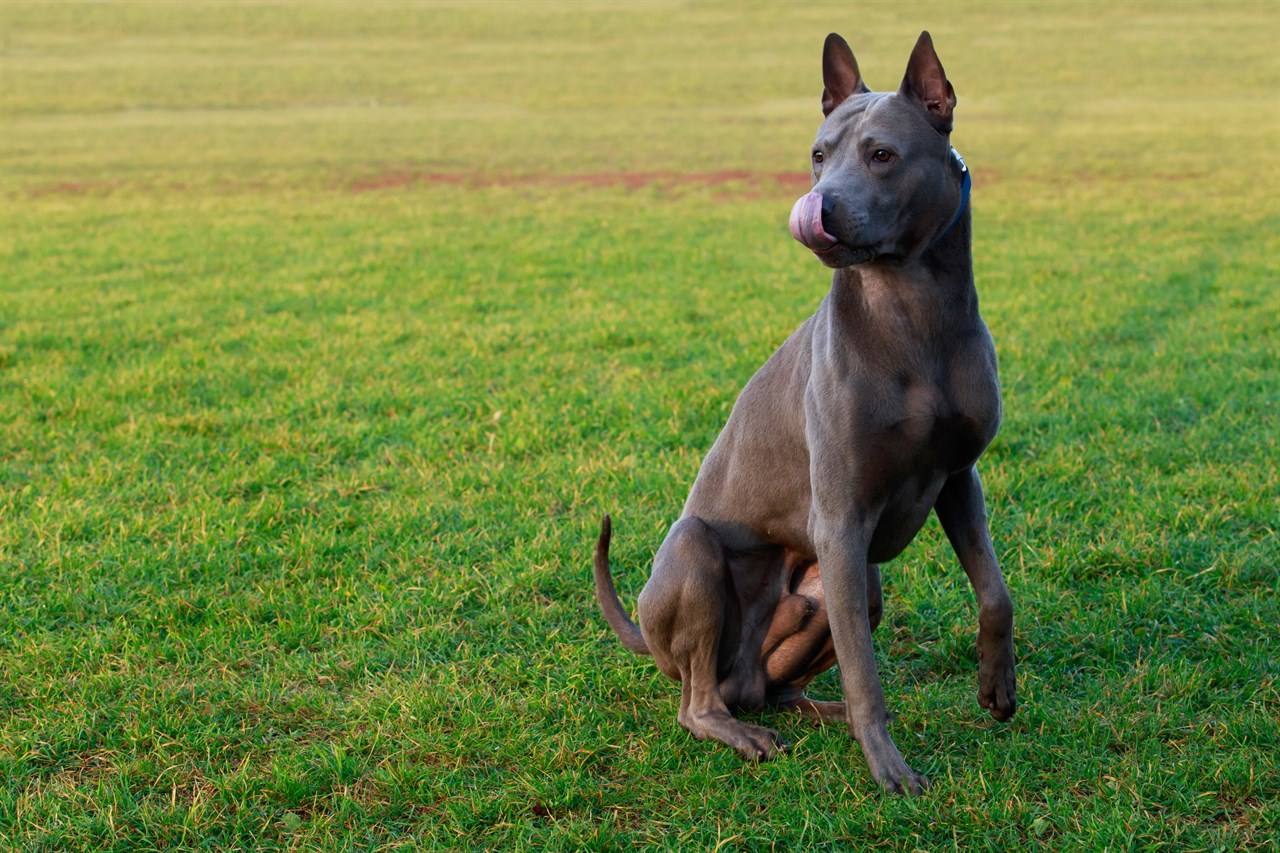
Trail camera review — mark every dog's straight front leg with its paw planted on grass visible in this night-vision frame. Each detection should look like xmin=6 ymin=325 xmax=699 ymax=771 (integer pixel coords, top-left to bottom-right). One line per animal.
xmin=810 ymin=507 xmax=929 ymax=794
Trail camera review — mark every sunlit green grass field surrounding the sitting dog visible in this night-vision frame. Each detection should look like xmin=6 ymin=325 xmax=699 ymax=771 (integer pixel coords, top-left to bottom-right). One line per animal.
xmin=0 ymin=0 xmax=1280 ymax=853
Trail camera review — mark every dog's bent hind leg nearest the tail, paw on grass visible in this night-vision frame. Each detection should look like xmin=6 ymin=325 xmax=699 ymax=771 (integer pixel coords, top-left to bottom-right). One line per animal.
xmin=637 ymin=517 xmax=786 ymax=761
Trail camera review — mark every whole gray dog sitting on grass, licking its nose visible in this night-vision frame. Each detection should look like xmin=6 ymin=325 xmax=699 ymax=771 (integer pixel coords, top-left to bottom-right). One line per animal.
xmin=595 ymin=32 xmax=1016 ymax=794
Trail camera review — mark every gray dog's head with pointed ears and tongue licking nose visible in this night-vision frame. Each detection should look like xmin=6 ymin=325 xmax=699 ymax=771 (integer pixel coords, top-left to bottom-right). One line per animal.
xmin=791 ymin=32 xmax=966 ymax=268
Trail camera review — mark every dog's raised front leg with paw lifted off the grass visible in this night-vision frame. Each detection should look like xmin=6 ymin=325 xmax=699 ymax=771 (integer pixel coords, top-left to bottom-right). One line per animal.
xmin=933 ymin=466 xmax=1018 ymax=720
